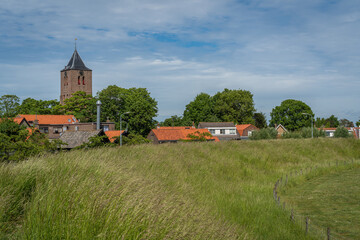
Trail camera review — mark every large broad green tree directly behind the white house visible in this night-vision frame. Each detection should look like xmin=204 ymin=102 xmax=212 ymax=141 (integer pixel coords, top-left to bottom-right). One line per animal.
xmin=213 ymin=88 xmax=255 ymax=124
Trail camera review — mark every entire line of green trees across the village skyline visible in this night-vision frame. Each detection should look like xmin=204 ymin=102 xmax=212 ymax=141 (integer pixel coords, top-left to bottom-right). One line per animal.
xmin=0 ymin=85 xmax=360 ymax=137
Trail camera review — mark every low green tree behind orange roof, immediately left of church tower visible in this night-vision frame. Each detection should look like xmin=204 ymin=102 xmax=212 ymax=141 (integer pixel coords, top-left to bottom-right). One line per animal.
xmin=17 ymin=98 xmax=60 ymax=115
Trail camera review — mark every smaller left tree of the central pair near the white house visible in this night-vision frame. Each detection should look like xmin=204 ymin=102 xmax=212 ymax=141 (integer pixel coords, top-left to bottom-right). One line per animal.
xmin=183 ymin=93 xmax=219 ymax=125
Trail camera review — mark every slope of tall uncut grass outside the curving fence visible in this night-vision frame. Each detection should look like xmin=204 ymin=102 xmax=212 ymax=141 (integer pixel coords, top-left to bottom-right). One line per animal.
xmin=0 ymin=139 xmax=360 ymax=239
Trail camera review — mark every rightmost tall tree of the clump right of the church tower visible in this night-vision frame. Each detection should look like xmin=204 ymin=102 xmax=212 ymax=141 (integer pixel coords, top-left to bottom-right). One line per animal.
xmin=123 ymin=88 xmax=158 ymax=137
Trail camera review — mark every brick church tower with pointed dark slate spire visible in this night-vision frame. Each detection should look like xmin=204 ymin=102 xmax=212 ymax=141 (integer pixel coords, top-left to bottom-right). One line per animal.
xmin=60 ymin=47 xmax=92 ymax=104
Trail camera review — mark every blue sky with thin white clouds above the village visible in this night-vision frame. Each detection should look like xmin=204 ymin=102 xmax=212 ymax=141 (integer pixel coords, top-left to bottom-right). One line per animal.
xmin=0 ymin=0 xmax=360 ymax=122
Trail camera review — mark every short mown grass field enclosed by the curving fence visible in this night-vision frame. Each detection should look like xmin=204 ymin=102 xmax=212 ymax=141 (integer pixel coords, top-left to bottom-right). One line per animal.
xmin=282 ymin=165 xmax=360 ymax=239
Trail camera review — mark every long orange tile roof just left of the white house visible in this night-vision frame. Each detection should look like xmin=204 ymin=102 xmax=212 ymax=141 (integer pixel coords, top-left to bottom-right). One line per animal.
xmin=152 ymin=128 xmax=219 ymax=141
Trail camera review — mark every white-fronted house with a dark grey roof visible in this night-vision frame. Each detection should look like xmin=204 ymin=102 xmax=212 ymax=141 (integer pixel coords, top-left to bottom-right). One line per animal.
xmin=198 ymin=122 xmax=240 ymax=141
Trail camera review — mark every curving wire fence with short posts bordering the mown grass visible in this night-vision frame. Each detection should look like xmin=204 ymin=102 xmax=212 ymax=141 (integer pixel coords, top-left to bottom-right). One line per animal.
xmin=273 ymin=160 xmax=359 ymax=240
